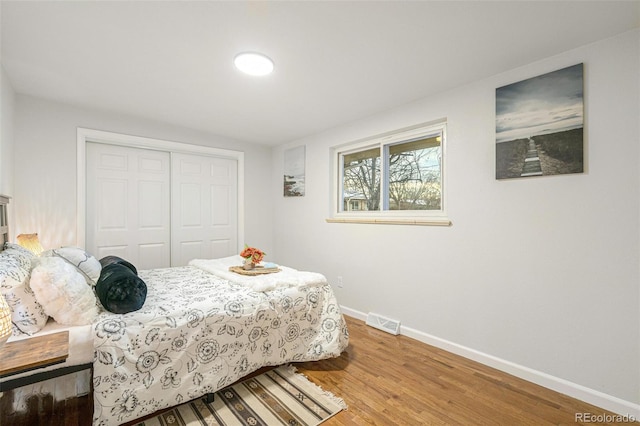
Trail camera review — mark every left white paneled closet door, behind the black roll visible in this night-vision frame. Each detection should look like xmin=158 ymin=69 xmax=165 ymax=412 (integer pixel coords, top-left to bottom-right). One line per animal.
xmin=86 ymin=143 xmax=171 ymax=269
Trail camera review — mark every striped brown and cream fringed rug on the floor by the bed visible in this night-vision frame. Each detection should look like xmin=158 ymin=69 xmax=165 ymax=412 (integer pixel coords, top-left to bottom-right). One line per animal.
xmin=136 ymin=366 xmax=347 ymax=426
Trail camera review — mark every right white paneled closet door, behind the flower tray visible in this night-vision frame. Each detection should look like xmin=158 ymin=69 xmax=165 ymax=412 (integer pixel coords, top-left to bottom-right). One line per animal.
xmin=171 ymin=153 xmax=238 ymax=266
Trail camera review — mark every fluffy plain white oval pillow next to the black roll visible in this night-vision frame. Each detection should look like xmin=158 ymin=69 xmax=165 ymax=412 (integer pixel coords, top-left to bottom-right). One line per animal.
xmin=31 ymin=257 xmax=98 ymax=325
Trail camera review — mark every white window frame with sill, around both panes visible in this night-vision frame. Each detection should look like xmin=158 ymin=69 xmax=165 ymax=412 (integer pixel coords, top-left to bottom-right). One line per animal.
xmin=326 ymin=120 xmax=451 ymax=226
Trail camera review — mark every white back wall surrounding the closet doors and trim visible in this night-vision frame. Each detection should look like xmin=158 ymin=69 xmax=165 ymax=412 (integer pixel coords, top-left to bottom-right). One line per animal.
xmin=12 ymin=95 xmax=272 ymax=252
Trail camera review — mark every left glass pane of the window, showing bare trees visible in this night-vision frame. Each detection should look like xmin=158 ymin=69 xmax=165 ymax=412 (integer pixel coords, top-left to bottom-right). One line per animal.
xmin=342 ymin=148 xmax=380 ymax=211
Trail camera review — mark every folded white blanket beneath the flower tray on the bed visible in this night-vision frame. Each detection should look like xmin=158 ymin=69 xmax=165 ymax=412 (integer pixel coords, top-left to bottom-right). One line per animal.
xmin=189 ymin=256 xmax=327 ymax=291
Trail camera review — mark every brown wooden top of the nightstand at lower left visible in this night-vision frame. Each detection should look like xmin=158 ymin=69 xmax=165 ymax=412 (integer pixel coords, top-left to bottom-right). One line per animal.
xmin=0 ymin=331 xmax=69 ymax=377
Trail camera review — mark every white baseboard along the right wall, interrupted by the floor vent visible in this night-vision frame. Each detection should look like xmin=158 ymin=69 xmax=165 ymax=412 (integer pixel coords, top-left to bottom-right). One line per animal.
xmin=341 ymin=306 xmax=640 ymax=420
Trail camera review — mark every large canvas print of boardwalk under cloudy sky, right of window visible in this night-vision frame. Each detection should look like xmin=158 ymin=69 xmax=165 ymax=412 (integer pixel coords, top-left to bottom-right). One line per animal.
xmin=496 ymin=64 xmax=584 ymax=179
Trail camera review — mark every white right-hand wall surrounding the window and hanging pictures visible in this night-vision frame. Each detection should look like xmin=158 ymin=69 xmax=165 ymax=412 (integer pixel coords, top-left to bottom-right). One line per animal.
xmin=272 ymin=31 xmax=640 ymax=413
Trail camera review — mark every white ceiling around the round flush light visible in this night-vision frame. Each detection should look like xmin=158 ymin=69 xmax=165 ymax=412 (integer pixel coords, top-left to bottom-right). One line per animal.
xmin=0 ymin=0 xmax=640 ymax=145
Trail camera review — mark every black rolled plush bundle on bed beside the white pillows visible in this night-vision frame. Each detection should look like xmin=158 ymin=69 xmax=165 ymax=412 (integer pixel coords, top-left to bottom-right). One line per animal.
xmin=96 ymin=256 xmax=147 ymax=314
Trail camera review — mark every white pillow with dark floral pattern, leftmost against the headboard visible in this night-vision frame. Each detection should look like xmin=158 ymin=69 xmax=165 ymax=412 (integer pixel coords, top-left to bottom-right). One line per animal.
xmin=0 ymin=245 xmax=49 ymax=335
